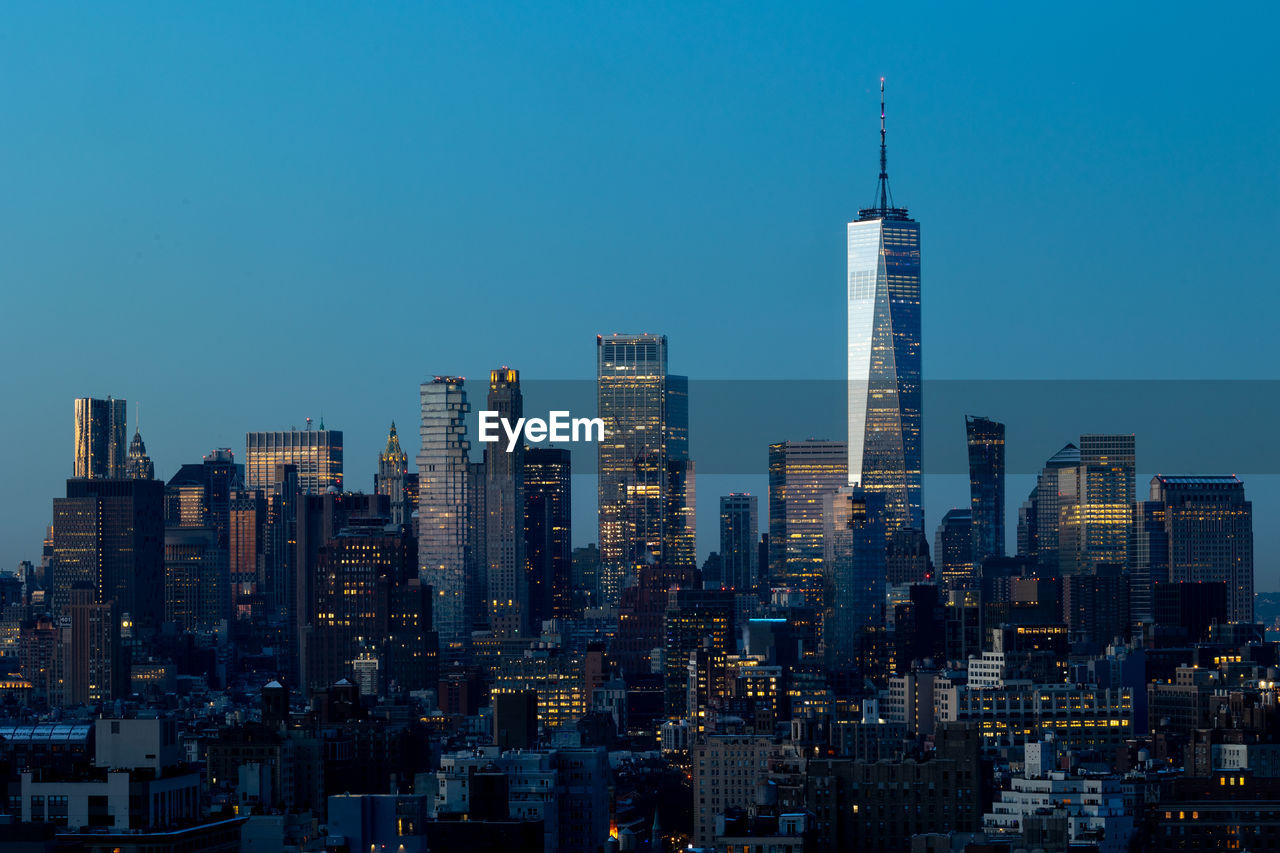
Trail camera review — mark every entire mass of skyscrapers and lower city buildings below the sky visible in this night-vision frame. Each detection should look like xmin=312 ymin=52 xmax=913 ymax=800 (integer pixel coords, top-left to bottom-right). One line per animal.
xmin=0 ymin=87 xmax=1280 ymax=853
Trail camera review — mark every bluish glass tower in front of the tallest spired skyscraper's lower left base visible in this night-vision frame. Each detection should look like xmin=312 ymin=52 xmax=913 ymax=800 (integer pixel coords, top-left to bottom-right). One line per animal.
xmin=822 ymin=485 xmax=886 ymax=672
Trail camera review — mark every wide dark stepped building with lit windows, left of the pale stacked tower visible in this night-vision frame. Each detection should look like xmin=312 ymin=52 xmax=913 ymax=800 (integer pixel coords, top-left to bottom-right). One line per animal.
xmin=305 ymin=517 xmax=420 ymax=690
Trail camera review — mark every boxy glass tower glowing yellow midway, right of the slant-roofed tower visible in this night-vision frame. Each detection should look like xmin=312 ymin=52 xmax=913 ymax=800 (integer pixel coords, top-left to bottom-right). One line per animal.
xmin=1057 ymin=434 xmax=1134 ymax=575
